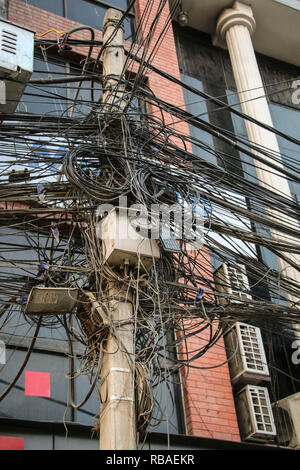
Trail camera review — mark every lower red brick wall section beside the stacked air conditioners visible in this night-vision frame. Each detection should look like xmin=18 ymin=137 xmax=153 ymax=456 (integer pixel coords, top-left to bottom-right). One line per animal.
xmin=178 ymin=246 xmax=240 ymax=441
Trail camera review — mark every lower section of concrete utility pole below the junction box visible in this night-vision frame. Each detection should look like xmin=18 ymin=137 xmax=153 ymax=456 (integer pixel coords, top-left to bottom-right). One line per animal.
xmin=100 ymin=283 xmax=136 ymax=450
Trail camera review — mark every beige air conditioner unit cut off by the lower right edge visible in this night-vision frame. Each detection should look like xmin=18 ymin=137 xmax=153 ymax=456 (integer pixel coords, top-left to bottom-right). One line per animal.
xmin=273 ymin=392 xmax=300 ymax=449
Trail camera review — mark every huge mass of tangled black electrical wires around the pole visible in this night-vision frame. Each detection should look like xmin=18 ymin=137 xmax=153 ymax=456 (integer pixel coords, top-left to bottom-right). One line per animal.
xmin=0 ymin=0 xmax=300 ymax=440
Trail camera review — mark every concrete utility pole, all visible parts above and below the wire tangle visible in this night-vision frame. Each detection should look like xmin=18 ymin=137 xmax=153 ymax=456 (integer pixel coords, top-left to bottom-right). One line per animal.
xmin=100 ymin=9 xmax=136 ymax=450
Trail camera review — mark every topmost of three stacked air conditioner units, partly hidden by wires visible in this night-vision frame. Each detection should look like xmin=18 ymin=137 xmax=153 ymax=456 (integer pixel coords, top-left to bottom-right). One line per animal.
xmin=214 ymin=263 xmax=252 ymax=305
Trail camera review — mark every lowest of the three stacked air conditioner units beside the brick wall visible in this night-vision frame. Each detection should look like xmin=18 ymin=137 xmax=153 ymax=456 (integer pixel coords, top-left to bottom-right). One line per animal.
xmin=235 ymin=385 xmax=276 ymax=442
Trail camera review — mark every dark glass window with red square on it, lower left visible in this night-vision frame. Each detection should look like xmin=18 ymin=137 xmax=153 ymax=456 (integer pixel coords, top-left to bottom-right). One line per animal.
xmin=0 ymin=347 xmax=100 ymax=426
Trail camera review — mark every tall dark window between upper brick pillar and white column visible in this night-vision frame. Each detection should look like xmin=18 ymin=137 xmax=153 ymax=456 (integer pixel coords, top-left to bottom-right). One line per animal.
xmin=174 ymin=26 xmax=242 ymax=176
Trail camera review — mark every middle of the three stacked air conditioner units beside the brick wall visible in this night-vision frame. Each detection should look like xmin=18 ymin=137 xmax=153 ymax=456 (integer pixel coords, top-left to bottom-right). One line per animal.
xmin=224 ymin=322 xmax=270 ymax=385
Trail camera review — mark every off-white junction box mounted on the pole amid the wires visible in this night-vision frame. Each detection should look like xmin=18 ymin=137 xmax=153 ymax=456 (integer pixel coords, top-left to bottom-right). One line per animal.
xmin=98 ymin=207 xmax=160 ymax=271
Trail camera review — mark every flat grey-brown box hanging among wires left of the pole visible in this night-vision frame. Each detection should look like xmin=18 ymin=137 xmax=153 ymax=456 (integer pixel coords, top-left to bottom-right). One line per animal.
xmin=24 ymin=287 xmax=78 ymax=315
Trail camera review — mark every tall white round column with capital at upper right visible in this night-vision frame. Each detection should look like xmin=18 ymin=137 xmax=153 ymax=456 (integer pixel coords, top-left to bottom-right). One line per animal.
xmin=216 ymin=1 xmax=300 ymax=302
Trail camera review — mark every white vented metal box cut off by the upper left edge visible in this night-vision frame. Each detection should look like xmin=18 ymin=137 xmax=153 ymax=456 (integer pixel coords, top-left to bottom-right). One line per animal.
xmin=0 ymin=18 xmax=34 ymax=113
